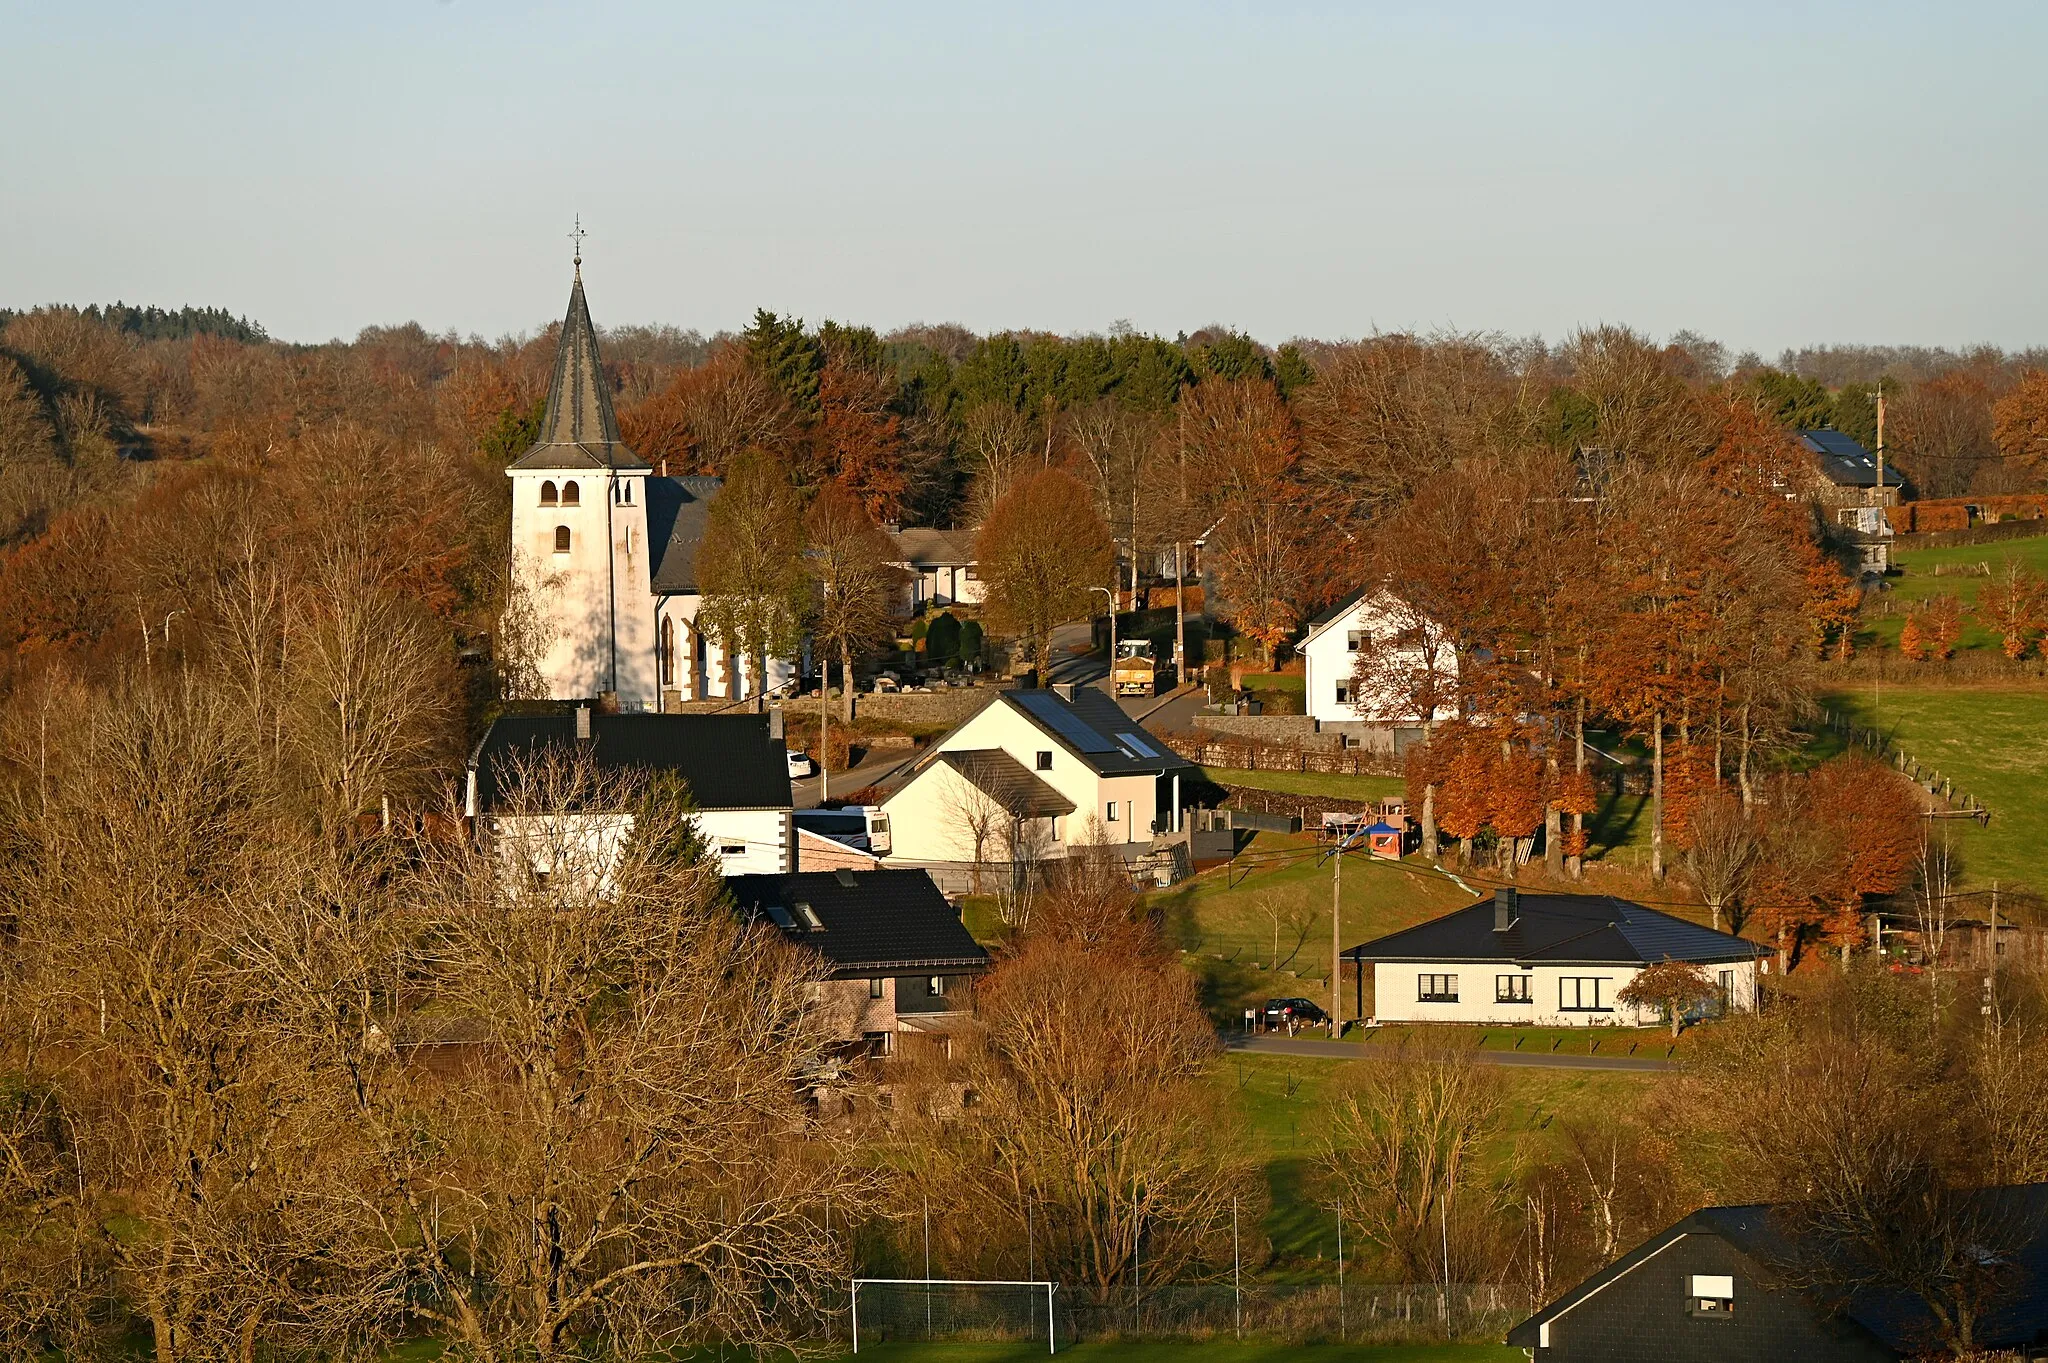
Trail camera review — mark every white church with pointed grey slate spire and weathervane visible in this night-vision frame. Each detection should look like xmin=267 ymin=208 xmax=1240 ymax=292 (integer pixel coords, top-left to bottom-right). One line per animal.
xmin=504 ymin=256 xmax=797 ymax=712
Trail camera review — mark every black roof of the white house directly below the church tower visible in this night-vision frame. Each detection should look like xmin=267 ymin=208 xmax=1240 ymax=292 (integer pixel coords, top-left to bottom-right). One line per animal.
xmin=469 ymin=706 xmax=791 ymax=810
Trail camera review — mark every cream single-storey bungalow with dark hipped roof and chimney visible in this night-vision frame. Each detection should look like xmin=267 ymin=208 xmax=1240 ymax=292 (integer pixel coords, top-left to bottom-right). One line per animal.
xmin=1343 ymin=888 xmax=1769 ymax=1027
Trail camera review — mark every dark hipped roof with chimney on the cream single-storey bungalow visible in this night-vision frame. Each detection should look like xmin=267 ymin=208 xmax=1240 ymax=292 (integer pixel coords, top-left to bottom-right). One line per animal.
xmin=1346 ymin=894 xmax=1769 ymax=966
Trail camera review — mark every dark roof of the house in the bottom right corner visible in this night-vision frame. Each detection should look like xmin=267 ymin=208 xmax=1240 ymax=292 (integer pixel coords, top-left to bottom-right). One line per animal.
xmin=1507 ymin=1183 xmax=2048 ymax=1357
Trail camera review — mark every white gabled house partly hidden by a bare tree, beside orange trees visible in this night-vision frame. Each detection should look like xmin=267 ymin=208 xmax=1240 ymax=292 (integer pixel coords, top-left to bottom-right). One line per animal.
xmin=1298 ymin=591 xmax=1458 ymax=731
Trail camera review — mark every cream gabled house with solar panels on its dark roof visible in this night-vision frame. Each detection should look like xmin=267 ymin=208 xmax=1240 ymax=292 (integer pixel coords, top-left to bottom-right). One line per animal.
xmin=883 ymin=686 xmax=1194 ymax=866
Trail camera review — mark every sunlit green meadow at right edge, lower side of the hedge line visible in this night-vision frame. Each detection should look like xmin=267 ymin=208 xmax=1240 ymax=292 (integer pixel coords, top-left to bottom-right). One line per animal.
xmin=1827 ymin=679 xmax=2048 ymax=890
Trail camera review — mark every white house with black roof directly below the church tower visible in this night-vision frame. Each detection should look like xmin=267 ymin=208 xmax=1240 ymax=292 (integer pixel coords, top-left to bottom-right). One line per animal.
xmin=465 ymin=706 xmax=797 ymax=876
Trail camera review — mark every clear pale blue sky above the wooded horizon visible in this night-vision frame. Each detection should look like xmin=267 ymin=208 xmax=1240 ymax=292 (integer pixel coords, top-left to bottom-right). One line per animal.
xmin=0 ymin=0 xmax=2048 ymax=354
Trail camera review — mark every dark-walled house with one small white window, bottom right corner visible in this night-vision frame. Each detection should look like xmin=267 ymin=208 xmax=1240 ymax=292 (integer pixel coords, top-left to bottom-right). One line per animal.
xmin=1507 ymin=1183 xmax=2048 ymax=1363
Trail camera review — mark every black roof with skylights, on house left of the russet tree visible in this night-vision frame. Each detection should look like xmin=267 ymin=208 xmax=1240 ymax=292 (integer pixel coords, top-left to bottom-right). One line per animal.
xmin=725 ymin=870 xmax=989 ymax=978
